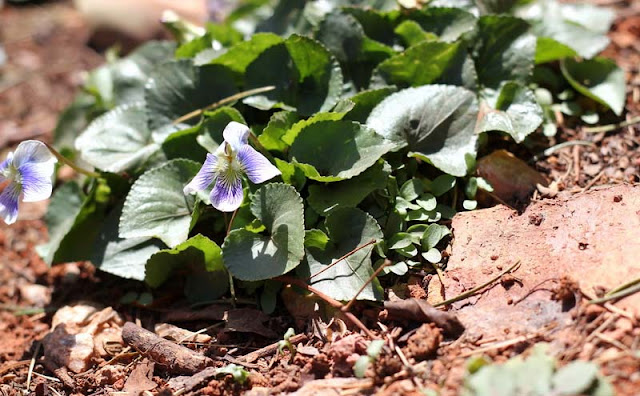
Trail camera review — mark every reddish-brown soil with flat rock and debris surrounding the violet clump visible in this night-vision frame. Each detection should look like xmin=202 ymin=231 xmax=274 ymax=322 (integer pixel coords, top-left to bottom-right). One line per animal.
xmin=0 ymin=1 xmax=640 ymax=395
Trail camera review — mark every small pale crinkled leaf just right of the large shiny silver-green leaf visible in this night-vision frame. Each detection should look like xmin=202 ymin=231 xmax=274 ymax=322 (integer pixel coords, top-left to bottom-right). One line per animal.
xmin=477 ymin=82 xmax=544 ymax=143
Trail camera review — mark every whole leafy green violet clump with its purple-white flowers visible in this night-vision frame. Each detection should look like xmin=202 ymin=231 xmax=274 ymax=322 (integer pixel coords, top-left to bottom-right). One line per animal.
xmin=2 ymin=1 xmax=625 ymax=392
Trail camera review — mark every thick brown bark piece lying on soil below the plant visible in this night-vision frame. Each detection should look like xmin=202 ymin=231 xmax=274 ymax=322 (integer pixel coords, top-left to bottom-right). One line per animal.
xmin=122 ymin=322 xmax=213 ymax=374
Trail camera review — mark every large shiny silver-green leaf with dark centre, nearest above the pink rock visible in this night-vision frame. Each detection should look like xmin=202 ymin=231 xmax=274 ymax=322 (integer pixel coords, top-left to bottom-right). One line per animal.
xmin=367 ymin=85 xmax=478 ymax=176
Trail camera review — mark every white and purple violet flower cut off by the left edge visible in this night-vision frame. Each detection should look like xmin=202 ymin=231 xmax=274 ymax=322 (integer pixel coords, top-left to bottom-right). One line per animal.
xmin=0 ymin=140 xmax=57 ymax=224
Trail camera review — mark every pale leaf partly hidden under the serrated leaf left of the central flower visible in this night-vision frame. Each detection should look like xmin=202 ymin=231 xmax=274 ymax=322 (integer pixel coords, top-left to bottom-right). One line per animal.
xmin=90 ymin=204 xmax=166 ymax=281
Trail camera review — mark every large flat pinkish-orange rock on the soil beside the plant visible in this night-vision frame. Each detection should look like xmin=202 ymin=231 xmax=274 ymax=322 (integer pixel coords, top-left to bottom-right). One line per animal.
xmin=446 ymin=185 xmax=640 ymax=338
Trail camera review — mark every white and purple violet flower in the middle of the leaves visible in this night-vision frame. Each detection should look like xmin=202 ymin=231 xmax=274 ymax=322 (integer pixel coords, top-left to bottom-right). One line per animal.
xmin=184 ymin=121 xmax=281 ymax=212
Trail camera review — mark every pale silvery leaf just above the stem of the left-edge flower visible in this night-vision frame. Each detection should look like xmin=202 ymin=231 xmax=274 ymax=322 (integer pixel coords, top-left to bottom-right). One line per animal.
xmin=76 ymin=102 xmax=166 ymax=173
